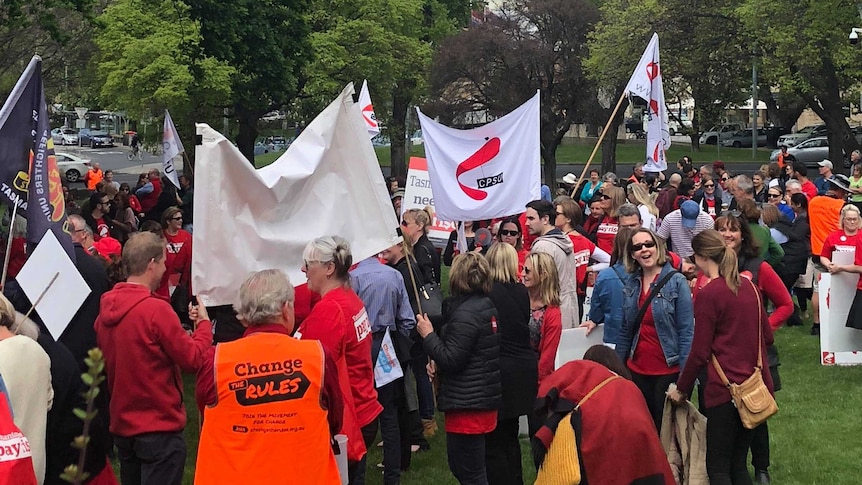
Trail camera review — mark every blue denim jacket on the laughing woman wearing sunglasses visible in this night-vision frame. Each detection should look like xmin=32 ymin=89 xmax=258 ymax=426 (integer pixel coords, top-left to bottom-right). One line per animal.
xmin=616 ymin=263 xmax=694 ymax=370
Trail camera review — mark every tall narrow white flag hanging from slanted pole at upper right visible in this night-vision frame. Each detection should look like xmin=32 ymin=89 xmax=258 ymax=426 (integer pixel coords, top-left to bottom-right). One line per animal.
xmin=626 ymin=33 xmax=670 ymax=172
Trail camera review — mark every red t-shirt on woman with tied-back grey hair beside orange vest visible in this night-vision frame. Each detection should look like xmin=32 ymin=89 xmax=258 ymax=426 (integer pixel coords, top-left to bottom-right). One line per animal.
xmin=296 ymin=288 xmax=383 ymax=428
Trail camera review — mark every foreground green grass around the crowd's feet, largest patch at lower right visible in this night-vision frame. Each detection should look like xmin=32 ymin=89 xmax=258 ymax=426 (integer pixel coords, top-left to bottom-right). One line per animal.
xmin=167 ymin=267 xmax=862 ymax=485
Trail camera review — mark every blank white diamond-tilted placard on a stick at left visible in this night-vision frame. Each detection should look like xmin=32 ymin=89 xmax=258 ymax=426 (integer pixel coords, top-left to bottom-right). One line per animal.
xmin=15 ymin=231 xmax=90 ymax=340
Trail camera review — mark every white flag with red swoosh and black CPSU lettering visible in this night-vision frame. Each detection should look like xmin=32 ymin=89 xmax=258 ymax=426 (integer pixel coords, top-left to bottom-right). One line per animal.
xmin=416 ymin=92 xmax=541 ymax=221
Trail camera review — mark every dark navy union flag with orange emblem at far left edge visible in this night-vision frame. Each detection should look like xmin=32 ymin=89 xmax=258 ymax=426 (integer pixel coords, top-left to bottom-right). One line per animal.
xmin=0 ymin=56 xmax=75 ymax=261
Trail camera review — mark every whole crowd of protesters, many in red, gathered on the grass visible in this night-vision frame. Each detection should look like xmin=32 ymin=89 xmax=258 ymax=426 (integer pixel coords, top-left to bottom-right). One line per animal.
xmin=0 ymin=154 xmax=862 ymax=485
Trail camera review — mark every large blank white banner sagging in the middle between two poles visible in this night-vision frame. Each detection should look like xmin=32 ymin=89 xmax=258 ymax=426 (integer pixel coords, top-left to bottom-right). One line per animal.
xmin=192 ymin=84 xmax=401 ymax=305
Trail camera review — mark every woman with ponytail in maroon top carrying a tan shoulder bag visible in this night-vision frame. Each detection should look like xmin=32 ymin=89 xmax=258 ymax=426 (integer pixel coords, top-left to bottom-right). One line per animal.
xmin=669 ymin=229 xmax=783 ymax=485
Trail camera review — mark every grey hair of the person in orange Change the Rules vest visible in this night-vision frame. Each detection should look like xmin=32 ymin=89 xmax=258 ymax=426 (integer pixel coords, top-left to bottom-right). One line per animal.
xmin=234 ymin=269 xmax=294 ymax=325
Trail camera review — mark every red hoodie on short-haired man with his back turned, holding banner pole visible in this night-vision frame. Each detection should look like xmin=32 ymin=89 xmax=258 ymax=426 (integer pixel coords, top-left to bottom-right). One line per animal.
xmin=94 ymin=283 xmax=212 ymax=437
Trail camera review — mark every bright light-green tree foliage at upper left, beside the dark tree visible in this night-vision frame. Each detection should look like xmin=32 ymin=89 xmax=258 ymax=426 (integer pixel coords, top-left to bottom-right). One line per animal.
xmin=96 ymin=0 xmax=235 ymax=119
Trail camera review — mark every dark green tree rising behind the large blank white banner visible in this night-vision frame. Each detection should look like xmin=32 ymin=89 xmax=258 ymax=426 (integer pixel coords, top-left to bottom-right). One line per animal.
xmin=186 ymin=0 xmax=311 ymax=162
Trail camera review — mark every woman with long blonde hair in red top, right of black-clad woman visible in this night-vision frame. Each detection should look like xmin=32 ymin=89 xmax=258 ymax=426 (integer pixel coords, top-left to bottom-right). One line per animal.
xmin=522 ymin=253 xmax=563 ymax=385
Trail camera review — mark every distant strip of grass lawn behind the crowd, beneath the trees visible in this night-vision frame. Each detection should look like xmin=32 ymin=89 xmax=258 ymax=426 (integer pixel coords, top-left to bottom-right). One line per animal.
xmin=255 ymin=139 xmax=772 ymax=168
